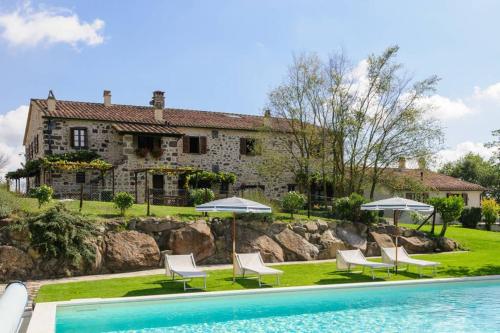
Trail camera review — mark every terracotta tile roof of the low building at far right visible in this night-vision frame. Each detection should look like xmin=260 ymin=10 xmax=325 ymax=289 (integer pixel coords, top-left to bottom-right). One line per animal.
xmin=388 ymin=169 xmax=486 ymax=191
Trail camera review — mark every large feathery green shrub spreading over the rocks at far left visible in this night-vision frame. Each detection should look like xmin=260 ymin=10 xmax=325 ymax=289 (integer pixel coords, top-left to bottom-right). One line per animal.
xmin=9 ymin=204 xmax=97 ymax=266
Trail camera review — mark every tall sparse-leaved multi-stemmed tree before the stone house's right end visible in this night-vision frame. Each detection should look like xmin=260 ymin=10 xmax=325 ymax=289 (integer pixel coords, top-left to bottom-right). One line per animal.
xmin=264 ymin=46 xmax=442 ymax=208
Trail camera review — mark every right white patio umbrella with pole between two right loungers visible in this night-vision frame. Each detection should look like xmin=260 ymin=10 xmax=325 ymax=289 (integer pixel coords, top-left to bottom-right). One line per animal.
xmin=361 ymin=197 xmax=434 ymax=273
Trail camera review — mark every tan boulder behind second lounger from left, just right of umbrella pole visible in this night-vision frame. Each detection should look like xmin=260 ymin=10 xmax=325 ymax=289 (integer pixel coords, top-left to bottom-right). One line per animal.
xmin=232 ymin=227 xmax=285 ymax=262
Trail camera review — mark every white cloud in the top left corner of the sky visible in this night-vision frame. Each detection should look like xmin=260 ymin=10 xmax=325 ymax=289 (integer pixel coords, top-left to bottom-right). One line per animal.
xmin=0 ymin=3 xmax=104 ymax=47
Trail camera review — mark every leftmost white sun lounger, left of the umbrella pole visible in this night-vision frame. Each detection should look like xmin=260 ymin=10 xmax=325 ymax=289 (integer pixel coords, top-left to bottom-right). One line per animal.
xmin=165 ymin=253 xmax=207 ymax=290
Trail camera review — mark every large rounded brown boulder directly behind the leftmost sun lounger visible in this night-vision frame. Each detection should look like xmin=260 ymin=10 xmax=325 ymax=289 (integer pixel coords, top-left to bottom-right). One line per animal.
xmin=168 ymin=220 xmax=215 ymax=261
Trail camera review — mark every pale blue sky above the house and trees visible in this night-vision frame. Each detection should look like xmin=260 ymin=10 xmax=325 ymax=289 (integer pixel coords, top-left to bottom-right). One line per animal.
xmin=0 ymin=0 xmax=500 ymax=171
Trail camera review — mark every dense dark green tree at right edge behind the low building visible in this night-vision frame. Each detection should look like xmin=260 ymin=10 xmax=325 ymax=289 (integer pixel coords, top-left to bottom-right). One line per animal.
xmin=439 ymin=153 xmax=500 ymax=201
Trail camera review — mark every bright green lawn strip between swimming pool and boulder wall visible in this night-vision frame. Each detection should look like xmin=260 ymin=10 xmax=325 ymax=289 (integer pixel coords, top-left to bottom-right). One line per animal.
xmin=36 ymin=227 xmax=500 ymax=302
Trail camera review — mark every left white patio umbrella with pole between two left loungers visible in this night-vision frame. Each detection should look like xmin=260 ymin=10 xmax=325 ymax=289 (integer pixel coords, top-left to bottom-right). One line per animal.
xmin=196 ymin=197 xmax=271 ymax=282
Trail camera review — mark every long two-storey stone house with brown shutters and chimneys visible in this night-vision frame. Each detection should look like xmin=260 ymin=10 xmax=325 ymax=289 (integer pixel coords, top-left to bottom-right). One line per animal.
xmin=23 ymin=91 xmax=295 ymax=202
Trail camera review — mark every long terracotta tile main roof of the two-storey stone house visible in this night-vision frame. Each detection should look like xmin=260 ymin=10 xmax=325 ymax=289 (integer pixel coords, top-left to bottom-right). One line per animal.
xmin=32 ymin=99 xmax=286 ymax=130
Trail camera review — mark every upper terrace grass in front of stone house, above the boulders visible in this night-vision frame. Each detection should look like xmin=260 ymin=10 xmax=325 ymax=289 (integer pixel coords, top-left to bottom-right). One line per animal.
xmin=14 ymin=197 xmax=328 ymax=221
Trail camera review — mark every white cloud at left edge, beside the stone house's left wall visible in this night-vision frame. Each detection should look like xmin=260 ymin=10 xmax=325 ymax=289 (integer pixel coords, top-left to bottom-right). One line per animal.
xmin=0 ymin=105 xmax=29 ymax=175
